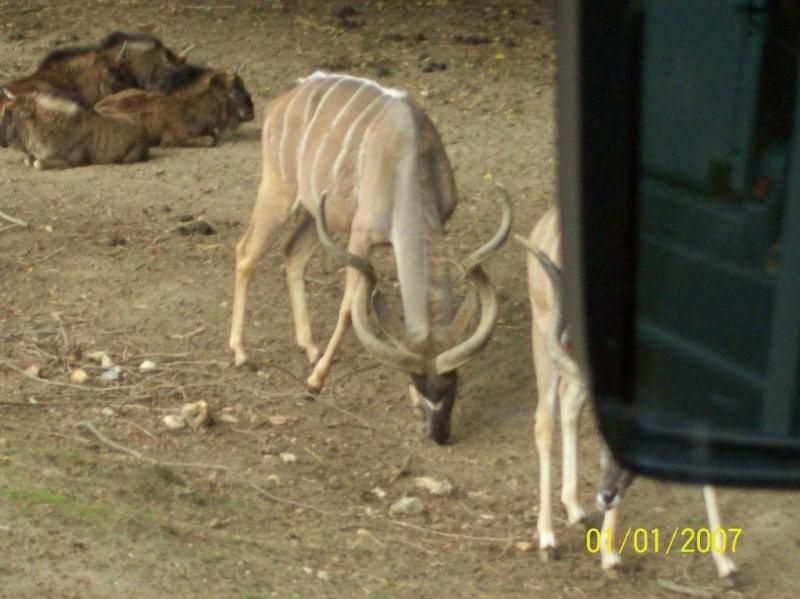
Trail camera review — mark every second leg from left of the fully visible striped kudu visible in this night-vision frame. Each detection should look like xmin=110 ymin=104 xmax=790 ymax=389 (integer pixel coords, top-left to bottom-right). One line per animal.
xmin=285 ymin=214 xmax=320 ymax=365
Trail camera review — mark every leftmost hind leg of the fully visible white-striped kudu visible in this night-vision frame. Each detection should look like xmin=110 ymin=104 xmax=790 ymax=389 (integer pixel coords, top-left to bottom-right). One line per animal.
xmin=229 ymin=170 xmax=294 ymax=366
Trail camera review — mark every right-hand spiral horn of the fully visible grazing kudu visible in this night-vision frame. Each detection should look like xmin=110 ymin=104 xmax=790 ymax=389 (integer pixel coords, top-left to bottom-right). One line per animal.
xmin=434 ymin=186 xmax=511 ymax=374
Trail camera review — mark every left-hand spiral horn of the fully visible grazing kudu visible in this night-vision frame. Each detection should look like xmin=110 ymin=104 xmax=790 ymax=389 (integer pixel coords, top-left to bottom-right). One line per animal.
xmin=316 ymin=192 xmax=425 ymax=374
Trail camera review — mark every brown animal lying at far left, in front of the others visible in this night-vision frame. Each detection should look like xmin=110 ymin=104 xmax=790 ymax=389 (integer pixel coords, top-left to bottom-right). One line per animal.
xmin=0 ymin=90 xmax=148 ymax=170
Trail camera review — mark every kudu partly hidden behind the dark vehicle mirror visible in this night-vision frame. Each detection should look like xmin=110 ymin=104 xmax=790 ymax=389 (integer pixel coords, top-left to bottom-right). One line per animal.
xmin=523 ymin=207 xmax=736 ymax=578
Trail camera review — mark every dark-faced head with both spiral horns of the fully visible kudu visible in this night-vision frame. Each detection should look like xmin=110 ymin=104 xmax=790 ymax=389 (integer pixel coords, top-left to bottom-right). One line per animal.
xmin=317 ymin=188 xmax=511 ymax=444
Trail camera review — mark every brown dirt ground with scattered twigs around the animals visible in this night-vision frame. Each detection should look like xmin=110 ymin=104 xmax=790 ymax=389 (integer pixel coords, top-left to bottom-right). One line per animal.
xmin=0 ymin=0 xmax=800 ymax=597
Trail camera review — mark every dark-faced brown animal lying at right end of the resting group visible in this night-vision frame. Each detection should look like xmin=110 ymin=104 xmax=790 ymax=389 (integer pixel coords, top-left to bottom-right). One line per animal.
xmin=95 ymin=65 xmax=253 ymax=147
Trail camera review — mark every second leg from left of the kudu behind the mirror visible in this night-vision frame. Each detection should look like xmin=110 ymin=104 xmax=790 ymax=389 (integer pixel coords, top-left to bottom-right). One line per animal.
xmin=559 ymin=381 xmax=586 ymax=525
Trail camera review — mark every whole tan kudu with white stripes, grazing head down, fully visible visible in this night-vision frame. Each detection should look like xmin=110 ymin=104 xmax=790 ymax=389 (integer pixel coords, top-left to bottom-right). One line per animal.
xmin=230 ymin=72 xmax=511 ymax=443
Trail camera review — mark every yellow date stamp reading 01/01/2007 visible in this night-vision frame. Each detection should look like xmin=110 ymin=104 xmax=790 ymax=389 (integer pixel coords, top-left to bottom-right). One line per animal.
xmin=586 ymin=526 xmax=742 ymax=555
